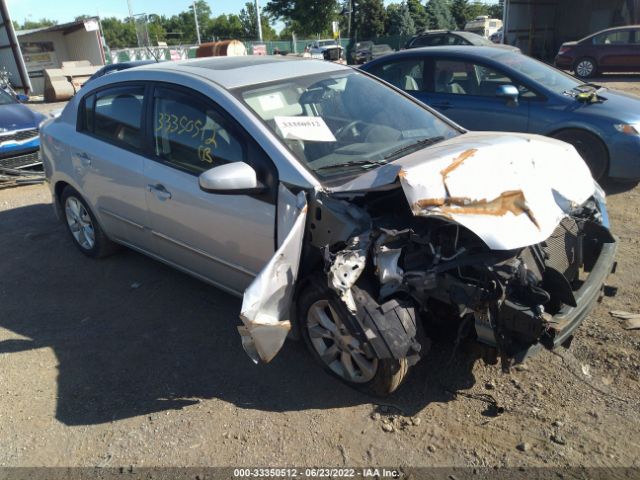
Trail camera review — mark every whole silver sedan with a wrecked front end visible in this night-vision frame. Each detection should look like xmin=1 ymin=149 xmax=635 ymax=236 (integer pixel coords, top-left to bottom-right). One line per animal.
xmin=42 ymin=57 xmax=616 ymax=395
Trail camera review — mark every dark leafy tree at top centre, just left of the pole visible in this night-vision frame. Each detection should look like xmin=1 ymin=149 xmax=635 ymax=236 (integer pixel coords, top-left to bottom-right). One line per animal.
xmin=264 ymin=0 xmax=338 ymax=35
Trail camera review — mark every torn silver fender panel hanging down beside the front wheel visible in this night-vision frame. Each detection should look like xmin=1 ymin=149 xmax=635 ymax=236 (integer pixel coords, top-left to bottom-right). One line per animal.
xmin=238 ymin=186 xmax=307 ymax=363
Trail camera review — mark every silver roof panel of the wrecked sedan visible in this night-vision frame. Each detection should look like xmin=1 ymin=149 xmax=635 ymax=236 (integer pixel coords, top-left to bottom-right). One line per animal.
xmin=138 ymin=55 xmax=353 ymax=89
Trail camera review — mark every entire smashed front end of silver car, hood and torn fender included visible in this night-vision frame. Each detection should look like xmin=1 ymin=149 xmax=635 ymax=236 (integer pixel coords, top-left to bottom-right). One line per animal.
xmin=240 ymin=133 xmax=616 ymax=391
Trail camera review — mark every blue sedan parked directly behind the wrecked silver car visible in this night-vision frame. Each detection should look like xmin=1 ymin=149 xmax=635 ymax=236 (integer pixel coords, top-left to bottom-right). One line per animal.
xmin=361 ymin=47 xmax=640 ymax=180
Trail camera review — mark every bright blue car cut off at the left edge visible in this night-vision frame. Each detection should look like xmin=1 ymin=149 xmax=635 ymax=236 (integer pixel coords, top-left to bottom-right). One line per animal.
xmin=0 ymin=89 xmax=46 ymax=169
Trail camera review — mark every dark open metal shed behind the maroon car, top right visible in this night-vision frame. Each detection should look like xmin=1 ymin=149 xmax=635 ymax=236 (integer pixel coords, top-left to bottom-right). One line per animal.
xmin=503 ymin=0 xmax=640 ymax=59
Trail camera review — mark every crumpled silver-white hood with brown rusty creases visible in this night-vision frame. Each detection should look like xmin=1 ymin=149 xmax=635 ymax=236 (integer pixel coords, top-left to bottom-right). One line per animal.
xmin=334 ymin=132 xmax=595 ymax=250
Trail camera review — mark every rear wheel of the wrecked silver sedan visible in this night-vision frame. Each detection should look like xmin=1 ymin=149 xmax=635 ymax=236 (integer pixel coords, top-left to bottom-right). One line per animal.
xmin=60 ymin=186 xmax=117 ymax=258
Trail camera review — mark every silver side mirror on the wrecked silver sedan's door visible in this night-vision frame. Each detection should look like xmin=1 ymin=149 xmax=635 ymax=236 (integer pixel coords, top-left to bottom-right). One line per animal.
xmin=198 ymin=162 xmax=265 ymax=195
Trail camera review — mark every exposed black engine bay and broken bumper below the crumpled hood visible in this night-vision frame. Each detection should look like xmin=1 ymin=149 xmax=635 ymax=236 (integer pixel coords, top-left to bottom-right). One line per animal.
xmin=316 ymin=189 xmax=614 ymax=365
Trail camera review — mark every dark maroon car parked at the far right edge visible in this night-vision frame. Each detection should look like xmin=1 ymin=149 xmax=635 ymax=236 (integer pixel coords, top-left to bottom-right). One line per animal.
xmin=555 ymin=25 xmax=640 ymax=78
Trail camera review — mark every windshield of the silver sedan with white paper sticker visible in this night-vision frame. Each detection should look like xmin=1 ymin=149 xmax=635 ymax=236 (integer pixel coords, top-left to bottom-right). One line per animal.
xmin=234 ymin=71 xmax=460 ymax=179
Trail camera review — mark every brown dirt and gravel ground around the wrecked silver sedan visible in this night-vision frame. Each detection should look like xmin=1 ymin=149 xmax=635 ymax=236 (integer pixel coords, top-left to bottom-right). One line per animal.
xmin=0 ymin=77 xmax=640 ymax=468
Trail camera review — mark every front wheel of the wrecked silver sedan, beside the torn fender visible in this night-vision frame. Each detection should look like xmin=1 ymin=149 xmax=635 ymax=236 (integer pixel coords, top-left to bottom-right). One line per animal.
xmin=297 ymin=279 xmax=409 ymax=396
